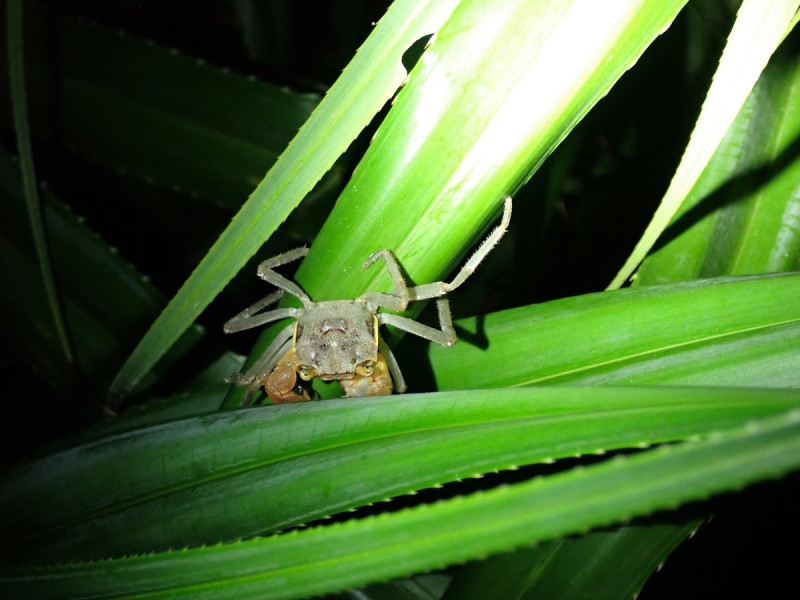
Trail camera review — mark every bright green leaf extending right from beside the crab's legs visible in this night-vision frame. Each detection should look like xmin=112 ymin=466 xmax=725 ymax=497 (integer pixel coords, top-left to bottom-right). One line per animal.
xmin=429 ymin=273 xmax=800 ymax=389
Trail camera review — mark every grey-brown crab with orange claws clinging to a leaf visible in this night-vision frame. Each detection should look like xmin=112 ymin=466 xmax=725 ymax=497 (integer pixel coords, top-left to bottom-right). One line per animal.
xmin=224 ymin=198 xmax=511 ymax=405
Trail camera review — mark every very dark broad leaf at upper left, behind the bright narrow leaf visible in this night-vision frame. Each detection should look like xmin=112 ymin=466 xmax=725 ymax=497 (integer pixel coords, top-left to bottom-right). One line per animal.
xmin=0 ymin=3 xmax=319 ymax=210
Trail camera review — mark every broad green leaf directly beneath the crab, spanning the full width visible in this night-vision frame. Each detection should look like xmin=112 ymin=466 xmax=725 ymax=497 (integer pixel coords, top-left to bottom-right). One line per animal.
xmin=0 ymin=387 xmax=798 ymax=561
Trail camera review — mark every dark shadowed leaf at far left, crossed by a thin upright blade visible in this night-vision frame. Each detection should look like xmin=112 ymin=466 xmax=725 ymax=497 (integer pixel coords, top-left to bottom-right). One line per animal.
xmin=0 ymin=150 xmax=209 ymax=396
